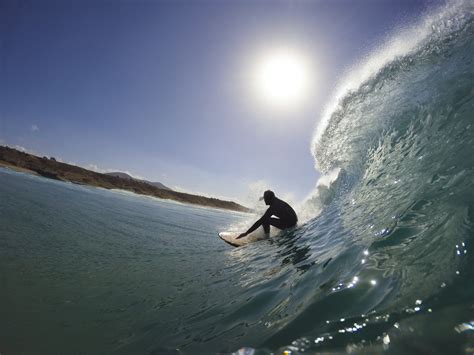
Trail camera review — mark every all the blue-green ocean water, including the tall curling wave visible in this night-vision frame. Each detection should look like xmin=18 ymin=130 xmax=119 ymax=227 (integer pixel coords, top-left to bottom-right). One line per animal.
xmin=0 ymin=1 xmax=474 ymax=354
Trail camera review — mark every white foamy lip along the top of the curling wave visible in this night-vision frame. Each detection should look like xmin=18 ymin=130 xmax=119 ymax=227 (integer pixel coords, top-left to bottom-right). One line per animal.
xmin=312 ymin=0 xmax=474 ymax=173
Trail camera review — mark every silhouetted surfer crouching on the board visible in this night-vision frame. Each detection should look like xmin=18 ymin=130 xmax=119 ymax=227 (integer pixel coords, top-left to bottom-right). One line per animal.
xmin=236 ymin=190 xmax=298 ymax=239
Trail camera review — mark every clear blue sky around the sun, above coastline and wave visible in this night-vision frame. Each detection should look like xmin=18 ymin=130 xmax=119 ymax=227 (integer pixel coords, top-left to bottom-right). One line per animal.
xmin=0 ymin=0 xmax=444 ymax=205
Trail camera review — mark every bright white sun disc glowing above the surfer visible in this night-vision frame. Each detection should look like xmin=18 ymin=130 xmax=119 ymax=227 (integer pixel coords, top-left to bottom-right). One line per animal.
xmin=254 ymin=50 xmax=312 ymax=108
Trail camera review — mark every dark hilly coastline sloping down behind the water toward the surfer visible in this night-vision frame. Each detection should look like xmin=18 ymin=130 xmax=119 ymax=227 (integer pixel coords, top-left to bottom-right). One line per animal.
xmin=0 ymin=146 xmax=251 ymax=213
